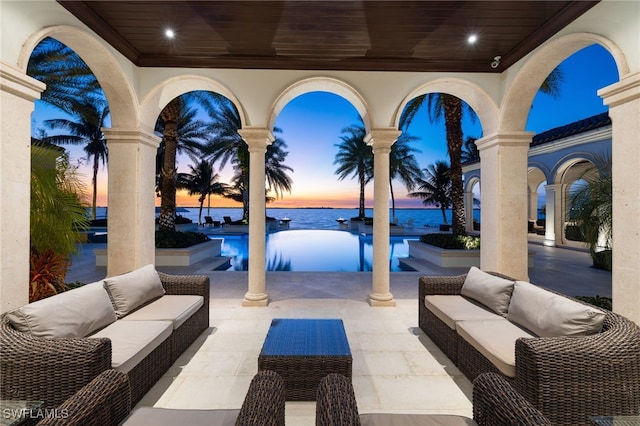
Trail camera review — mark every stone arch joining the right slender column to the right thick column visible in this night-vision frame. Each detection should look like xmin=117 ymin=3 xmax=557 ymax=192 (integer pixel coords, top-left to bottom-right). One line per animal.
xmin=393 ymin=78 xmax=498 ymax=135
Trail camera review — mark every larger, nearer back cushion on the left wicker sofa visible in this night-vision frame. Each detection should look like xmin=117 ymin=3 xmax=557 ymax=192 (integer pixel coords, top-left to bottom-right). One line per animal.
xmin=7 ymin=282 xmax=117 ymax=337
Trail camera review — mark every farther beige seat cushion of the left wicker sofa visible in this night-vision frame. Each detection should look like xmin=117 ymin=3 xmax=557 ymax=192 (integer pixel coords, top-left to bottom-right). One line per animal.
xmin=122 ymin=295 xmax=204 ymax=330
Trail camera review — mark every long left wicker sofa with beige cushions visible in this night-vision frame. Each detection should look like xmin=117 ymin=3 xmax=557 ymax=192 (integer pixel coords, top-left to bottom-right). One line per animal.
xmin=0 ymin=265 xmax=210 ymax=409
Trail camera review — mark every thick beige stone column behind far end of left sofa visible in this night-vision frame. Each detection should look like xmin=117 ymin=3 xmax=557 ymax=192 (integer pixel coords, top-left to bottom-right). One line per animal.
xmin=102 ymin=128 xmax=160 ymax=276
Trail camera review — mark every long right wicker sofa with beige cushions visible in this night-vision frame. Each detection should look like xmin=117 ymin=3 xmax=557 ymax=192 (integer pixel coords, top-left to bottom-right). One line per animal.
xmin=418 ymin=268 xmax=640 ymax=425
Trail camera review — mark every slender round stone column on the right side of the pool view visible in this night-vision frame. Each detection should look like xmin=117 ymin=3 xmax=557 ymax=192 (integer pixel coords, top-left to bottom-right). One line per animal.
xmin=368 ymin=129 xmax=400 ymax=306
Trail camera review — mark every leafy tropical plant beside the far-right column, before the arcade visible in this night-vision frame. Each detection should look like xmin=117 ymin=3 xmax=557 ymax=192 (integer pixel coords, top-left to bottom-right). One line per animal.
xmin=569 ymin=155 xmax=613 ymax=269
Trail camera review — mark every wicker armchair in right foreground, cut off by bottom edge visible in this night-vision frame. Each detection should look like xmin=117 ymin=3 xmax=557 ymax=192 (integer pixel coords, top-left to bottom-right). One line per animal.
xmin=316 ymin=373 xmax=551 ymax=426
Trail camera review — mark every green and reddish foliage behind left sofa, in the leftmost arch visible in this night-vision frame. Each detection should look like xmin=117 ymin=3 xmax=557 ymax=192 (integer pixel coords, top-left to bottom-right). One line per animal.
xmin=29 ymin=142 xmax=89 ymax=302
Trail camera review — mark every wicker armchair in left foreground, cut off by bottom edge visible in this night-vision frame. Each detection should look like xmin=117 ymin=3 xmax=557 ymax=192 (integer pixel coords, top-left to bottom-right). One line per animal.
xmin=32 ymin=370 xmax=285 ymax=426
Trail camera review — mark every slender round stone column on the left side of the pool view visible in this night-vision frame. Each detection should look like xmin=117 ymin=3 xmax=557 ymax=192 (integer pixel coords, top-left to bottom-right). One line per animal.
xmin=238 ymin=128 xmax=273 ymax=306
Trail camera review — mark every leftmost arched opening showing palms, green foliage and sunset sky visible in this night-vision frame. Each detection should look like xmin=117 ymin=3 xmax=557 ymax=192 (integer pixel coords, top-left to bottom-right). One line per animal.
xmin=27 ymin=37 xmax=111 ymax=301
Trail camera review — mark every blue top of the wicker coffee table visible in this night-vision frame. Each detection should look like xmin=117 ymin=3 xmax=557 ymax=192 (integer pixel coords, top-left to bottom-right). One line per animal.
xmin=260 ymin=318 xmax=351 ymax=356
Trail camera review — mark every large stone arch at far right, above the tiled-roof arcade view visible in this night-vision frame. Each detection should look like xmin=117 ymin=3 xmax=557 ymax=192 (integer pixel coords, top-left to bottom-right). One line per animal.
xmin=500 ymin=33 xmax=629 ymax=132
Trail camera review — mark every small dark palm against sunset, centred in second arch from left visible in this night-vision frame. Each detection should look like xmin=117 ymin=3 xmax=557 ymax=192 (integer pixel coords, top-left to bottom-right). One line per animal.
xmin=178 ymin=157 xmax=229 ymax=224
